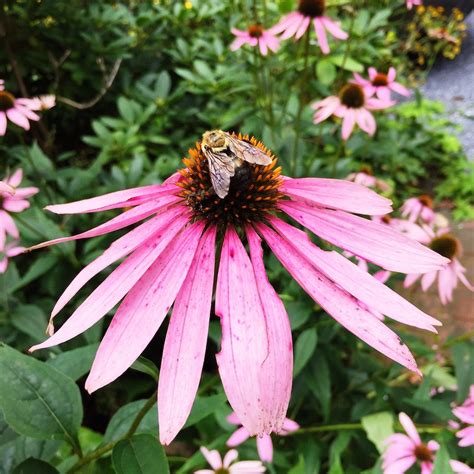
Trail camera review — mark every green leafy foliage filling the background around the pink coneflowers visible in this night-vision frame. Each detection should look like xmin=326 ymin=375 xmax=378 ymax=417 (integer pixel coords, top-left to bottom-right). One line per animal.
xmin=0 ymin=0 xmax=474 ymax=474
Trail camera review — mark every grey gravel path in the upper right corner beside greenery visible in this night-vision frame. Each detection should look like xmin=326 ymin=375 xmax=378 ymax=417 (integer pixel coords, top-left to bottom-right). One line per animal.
xmin=422 ymin=11 xmax=474 ymax=160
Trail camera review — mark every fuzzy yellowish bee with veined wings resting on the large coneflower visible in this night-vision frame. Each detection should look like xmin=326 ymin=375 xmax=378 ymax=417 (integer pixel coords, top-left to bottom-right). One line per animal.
xmin=201 ymin=130 xmax=272 ymax=199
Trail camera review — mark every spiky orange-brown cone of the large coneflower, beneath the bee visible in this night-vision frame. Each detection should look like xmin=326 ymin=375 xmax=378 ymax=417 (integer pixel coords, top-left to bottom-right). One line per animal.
xmin=178 ymin=134 xmax=283 ymax=228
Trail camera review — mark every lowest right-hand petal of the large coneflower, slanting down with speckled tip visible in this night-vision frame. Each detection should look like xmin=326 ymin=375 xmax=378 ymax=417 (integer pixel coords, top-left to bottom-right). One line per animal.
xmin=258 ymin=224 xmax=420 ymax=373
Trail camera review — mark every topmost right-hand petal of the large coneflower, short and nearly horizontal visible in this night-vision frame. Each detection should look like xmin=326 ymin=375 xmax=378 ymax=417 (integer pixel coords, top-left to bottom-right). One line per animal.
xmin=280 ymin=178 xmax=392 ymax=216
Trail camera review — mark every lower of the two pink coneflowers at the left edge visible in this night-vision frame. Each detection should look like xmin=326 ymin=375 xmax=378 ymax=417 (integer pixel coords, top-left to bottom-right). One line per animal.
xmin=0 ymin=169 xmax=39 ymax=248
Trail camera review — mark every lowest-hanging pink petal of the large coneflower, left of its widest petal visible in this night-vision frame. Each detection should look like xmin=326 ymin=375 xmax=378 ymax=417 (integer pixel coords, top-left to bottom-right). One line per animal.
xmin=158 ymin=227 xmax=216 ymax=445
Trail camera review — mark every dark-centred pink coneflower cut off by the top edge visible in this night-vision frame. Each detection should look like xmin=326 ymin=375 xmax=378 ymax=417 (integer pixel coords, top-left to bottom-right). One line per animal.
xmin=272 ymin=0 xmax=348 ymax=54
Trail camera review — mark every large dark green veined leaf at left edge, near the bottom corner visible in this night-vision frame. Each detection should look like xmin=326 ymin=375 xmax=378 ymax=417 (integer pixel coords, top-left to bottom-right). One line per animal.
xmin=0 ymin=345 xmax=82 ymax=445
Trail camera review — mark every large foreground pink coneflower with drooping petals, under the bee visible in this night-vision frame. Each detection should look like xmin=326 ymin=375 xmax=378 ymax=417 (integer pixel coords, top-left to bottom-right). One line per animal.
xmin=32 ymin=135 xmax=448 ymax=444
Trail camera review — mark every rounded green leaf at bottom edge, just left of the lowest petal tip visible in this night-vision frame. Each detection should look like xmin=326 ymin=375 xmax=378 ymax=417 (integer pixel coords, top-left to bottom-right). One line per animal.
xmin=112 ymin=434 xmax=170 ymax=474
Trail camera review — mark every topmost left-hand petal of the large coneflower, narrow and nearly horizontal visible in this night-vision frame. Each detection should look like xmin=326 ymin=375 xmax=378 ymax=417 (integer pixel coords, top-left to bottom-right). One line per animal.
xmin=45 ymin=184 xmax=179 ymax=214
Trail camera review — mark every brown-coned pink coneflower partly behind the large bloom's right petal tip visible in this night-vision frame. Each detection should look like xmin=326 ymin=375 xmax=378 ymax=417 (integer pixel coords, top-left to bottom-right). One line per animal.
xmin=404 ymin=223 xmax=474 ymax=304
